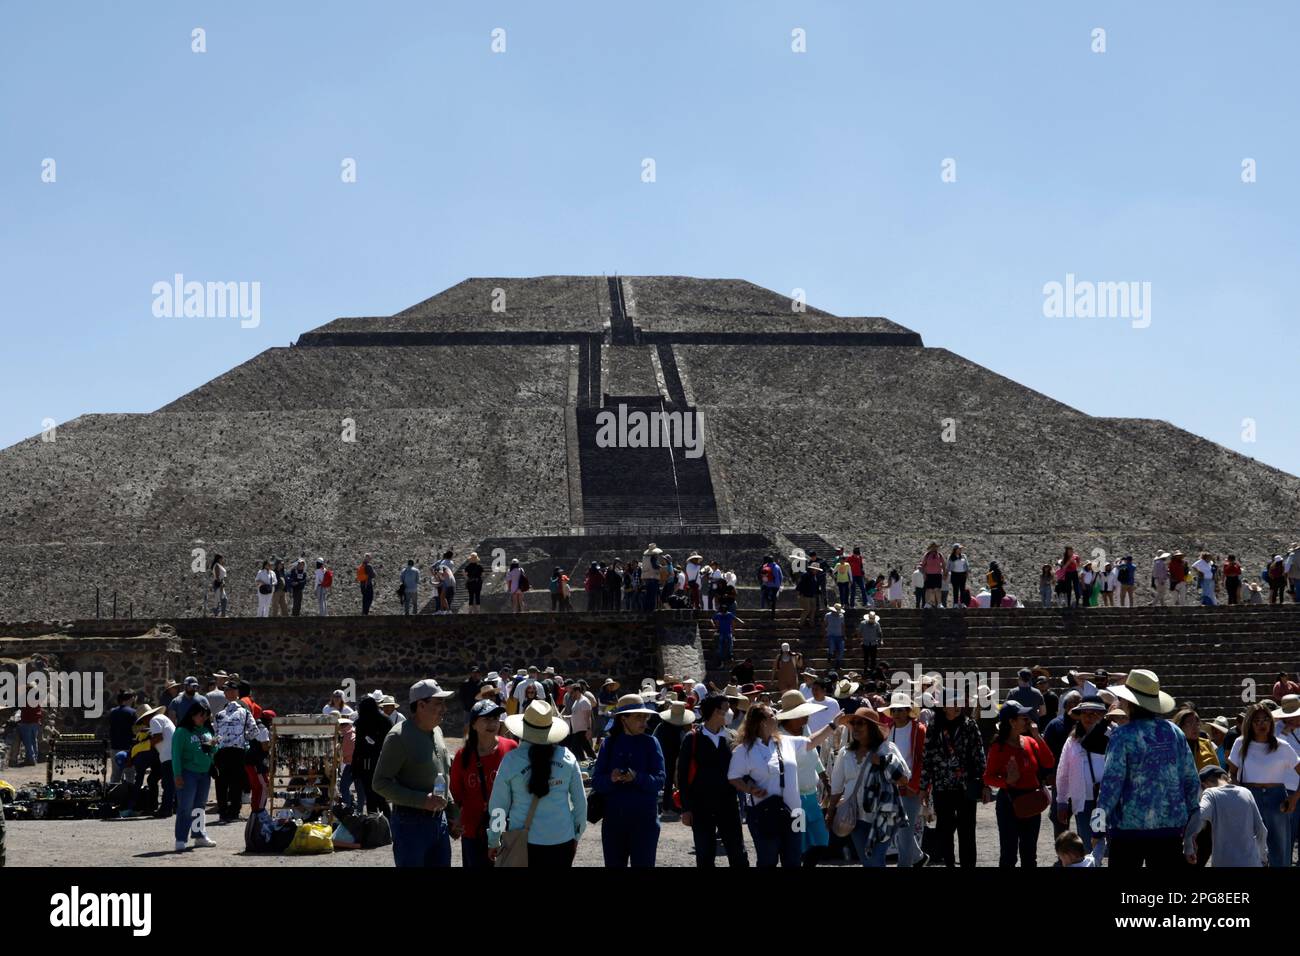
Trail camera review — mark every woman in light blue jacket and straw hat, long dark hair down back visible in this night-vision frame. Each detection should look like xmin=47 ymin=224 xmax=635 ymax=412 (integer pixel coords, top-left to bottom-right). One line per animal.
xmin=488 ymin=700 xmax=586 ymax=868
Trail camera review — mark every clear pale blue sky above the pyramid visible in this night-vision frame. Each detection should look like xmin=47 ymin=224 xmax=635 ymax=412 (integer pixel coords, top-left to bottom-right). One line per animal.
xmin=0 ymin=0 xmax=1300 ymax=479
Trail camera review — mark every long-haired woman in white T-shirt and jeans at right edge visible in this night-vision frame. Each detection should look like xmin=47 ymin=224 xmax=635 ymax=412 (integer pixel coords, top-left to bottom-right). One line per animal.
xmin=1227 ymin=704 xmax=1300 ymax=866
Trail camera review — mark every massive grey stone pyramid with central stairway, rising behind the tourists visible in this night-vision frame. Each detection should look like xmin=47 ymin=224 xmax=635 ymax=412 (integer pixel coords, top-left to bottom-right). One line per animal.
xmin=0 ymin=276 xmax=1300 ymax=620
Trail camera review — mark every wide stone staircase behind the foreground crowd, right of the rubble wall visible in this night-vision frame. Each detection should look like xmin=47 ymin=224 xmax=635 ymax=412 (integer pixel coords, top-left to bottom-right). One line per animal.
xmin=701 ymin=605 xmax=1300 ymax=719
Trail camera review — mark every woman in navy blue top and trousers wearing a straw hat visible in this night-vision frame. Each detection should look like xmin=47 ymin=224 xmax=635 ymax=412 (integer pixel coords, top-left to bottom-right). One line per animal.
xmin=592 ymin=693 xmax=667 ymax=868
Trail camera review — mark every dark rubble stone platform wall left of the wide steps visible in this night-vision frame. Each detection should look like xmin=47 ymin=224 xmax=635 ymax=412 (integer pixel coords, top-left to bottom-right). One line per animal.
xmin=0 ymin=611 xmax=703 ymax=732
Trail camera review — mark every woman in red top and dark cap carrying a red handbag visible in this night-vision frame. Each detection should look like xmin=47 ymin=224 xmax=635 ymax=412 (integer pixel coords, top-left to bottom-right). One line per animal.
xmin=984 ymin=701 xmax=1056 ymax=866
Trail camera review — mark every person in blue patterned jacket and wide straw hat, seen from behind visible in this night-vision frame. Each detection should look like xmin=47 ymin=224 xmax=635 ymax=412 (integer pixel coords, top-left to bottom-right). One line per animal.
xmin=1092 ymin=670 xmax=1196 ymax=869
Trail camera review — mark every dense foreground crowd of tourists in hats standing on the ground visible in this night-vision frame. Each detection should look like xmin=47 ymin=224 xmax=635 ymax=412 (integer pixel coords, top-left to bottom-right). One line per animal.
xmin=68 ymin=645 xmax=1300 ymax=868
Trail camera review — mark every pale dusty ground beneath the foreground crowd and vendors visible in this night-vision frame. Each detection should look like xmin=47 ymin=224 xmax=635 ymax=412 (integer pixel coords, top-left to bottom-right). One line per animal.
xmin=0 ymin=767 xmax=1056 ymax=866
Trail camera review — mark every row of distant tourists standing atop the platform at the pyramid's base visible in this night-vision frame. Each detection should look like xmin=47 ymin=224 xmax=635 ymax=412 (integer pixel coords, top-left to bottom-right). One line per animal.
xmin=197 ymin=541 xmax=1300 ymax=626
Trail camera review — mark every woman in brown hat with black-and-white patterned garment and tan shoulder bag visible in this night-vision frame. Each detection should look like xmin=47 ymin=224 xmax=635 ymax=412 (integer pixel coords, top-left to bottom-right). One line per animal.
xmin=827 ymin=706 xmax=911 ymax=866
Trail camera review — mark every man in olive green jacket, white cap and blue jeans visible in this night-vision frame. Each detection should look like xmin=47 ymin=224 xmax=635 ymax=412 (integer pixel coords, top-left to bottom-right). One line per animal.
xmin=374 ymin=679 xmax=460 ymax=866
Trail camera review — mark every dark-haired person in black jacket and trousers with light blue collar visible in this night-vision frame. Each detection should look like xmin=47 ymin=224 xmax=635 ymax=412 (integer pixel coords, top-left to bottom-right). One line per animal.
xmin=677 ymin=693 xmax=749 ymax=868
